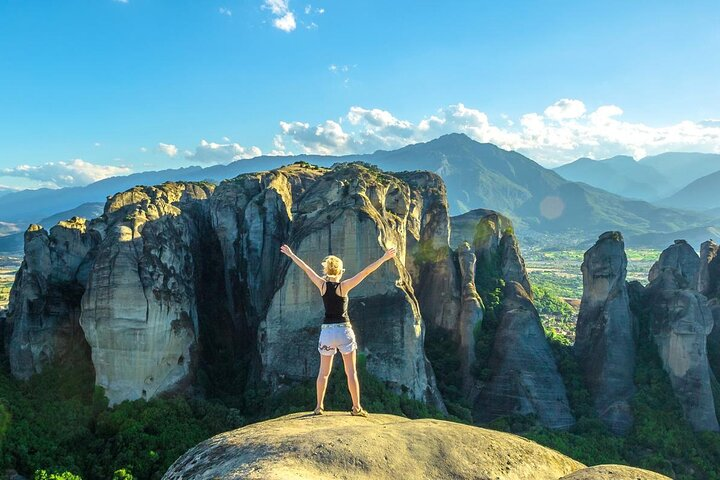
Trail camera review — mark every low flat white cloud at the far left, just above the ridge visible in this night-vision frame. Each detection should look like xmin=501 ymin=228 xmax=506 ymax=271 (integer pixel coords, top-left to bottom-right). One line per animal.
xmin=0 ymin=158 xmax=131 ymax=188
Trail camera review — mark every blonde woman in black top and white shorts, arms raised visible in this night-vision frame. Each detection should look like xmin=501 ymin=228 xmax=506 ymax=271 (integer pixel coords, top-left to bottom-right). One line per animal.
xmin=280 ymin=245 xmax=395 ymax=417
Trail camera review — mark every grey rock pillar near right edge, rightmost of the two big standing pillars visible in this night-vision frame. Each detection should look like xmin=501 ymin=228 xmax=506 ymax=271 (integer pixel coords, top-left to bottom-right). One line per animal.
xmin=645 ymin=244 xmax=719 ymax=431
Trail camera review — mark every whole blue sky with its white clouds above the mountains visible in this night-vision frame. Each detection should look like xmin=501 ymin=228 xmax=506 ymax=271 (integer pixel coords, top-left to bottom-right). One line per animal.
xmin=0 ymin=0 xmax=720 ymax=188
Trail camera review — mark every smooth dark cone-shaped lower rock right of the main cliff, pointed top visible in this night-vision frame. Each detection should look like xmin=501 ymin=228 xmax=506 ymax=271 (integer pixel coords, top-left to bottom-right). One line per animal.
xmin=475 ymin=281 xmax=575 ymax=429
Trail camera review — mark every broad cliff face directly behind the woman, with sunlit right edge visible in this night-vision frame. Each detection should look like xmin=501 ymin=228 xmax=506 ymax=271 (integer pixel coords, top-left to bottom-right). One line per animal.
xmin=250 ymin=165 xmax=447 ymax=409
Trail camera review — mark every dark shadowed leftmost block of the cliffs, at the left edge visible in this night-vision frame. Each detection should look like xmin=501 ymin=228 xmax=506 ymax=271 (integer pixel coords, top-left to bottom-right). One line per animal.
xmin=4 ymin=217 xmax=99 ymax=379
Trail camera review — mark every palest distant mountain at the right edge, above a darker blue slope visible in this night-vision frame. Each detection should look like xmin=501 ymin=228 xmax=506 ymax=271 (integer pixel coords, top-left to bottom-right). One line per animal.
xmin=639 ymin=152 xmax=720 ymax=193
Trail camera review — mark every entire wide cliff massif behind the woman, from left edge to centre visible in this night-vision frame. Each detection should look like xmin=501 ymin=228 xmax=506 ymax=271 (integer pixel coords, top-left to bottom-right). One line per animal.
xmin=4 ymin=164 xmax=456 ymax=411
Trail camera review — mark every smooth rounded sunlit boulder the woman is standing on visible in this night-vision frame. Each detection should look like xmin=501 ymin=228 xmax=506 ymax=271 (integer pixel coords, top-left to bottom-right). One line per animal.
xmin=163 ymin=412 xmax=584 ymax=480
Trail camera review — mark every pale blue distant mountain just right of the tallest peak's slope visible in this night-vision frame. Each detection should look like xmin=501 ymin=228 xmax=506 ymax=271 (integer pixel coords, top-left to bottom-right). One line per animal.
xmin=555 ymin=155 xmax=675 ymax=201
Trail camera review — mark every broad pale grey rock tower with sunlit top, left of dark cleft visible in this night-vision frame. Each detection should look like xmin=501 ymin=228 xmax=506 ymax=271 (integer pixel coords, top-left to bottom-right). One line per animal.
xmin=80 ymin=183 xmax=212 ymax=404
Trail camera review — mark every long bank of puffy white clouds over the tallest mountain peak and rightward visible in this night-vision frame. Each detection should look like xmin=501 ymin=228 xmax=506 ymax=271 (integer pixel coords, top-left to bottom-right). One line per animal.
xmin=274 ymin=98 xmax=720 ymax=166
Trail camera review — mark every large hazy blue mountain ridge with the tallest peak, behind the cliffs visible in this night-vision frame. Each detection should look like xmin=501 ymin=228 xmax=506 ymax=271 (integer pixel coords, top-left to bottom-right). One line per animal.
xmin=0 ymin=134 xmax=712 ymax=249
